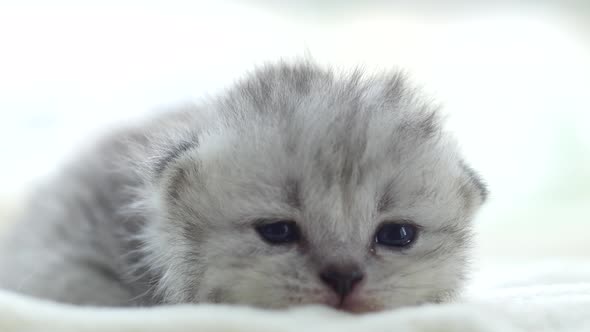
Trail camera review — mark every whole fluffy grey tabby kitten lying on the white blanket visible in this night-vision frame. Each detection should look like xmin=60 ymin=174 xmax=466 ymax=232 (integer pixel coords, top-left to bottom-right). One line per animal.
xmin=0 ymin=63 xmax=486 ymax=312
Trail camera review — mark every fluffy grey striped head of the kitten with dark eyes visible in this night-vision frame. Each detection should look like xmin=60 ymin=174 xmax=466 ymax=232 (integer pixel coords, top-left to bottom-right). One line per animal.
xmin=140 ymin=65 xmax=486 ymax=312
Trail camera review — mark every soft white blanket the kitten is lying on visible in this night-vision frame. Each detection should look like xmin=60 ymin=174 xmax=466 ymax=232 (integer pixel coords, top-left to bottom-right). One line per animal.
xmin=0 ymin=260 xmax=590 ymax=332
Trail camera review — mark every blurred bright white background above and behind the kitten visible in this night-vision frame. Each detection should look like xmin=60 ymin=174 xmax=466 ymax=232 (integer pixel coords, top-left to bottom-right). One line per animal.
xmin=0 ymin=0 xmax=590 ymax=258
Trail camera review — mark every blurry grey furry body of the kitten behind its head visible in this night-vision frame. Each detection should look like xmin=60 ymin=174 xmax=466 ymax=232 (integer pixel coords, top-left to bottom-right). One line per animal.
xmin=0 ymin=128 xmax=145 ymax=305
